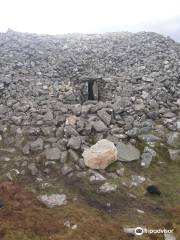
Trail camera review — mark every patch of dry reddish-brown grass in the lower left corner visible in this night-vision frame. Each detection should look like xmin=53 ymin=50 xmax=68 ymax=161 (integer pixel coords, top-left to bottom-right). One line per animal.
xmin=0 ymin=182 xmax=134 ymax=240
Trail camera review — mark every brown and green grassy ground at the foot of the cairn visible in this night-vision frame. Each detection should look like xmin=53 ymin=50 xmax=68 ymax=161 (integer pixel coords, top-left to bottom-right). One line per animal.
xmin=0 ymin=135 xmax=180 ymax=240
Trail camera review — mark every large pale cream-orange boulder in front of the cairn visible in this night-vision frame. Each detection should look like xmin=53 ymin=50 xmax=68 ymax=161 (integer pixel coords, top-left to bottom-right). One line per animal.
xmin=82 ymin=139 xmax=117 ymax=169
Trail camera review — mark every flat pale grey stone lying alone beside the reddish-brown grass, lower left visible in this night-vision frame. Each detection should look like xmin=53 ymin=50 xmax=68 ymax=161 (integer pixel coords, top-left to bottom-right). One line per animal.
xmin=38 ymin=194 xmax=67 ymax=208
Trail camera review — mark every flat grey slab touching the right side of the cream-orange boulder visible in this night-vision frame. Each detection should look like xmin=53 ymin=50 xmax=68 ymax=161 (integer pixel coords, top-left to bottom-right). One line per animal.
xmin=117 ymin=142 xmax=140 ymax=162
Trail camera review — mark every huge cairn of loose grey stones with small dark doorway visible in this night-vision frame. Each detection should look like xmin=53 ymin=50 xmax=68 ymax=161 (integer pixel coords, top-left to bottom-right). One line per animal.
xmin=0 ymin=31 xmax=180 ymax=181
